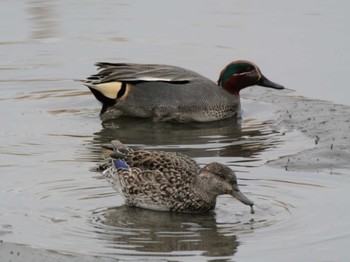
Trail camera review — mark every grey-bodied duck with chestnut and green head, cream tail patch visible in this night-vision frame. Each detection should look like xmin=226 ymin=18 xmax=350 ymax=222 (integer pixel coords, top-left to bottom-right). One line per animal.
xmin=80 ymin=60 xmax=284 ymax=122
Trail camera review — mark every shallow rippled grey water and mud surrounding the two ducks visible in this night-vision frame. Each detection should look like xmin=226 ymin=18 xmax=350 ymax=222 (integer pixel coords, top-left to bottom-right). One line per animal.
xmin=0 ymin=1 xmax=350 ymax=261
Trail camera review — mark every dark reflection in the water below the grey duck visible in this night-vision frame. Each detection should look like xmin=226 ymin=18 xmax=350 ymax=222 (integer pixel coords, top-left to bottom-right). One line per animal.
xmin=91 ymin=117 xmax=281 ymax=161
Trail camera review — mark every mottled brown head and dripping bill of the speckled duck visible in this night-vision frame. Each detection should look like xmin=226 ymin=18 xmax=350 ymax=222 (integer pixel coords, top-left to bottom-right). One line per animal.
xmin=197 ymin=162 xmax=254 ymax=214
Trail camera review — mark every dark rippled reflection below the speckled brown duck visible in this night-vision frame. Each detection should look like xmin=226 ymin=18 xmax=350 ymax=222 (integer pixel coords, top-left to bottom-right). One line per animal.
xmin=90 ymin=206 xmax=241 ymax=256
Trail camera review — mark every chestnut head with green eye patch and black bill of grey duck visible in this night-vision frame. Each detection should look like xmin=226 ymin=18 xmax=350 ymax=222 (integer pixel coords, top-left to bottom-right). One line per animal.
xmin=218 ymin=60 xmax=284 ymax=96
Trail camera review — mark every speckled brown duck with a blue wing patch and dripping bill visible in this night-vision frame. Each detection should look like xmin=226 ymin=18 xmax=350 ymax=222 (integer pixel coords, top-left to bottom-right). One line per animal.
xmin=96 ymin=140 xmax=254 ymax=213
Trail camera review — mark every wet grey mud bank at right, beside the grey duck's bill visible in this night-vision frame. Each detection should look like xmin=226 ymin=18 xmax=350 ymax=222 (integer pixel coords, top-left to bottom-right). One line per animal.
xmin=242 ymin=88 xmax=350 ymax=174
